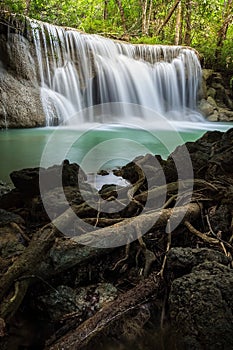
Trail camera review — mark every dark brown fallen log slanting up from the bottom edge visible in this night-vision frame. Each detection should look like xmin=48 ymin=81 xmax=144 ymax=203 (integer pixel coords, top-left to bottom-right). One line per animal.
xmin=46 ymin=272 xmax=163 ymax=350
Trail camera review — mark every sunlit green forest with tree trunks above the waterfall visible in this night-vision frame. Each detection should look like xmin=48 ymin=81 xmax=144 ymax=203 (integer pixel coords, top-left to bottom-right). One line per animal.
xmin=0 ymin=0 xmax=233 ymax=74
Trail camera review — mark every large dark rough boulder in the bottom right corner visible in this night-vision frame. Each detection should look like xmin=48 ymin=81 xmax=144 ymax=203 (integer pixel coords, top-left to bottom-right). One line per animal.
xmin=169 ymin=261 xmax=233 ymax=350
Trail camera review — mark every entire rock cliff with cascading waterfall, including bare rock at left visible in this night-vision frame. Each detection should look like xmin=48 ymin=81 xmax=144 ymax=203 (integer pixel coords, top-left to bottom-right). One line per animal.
xmin=0 ymin=13 xmax=206 ymax=128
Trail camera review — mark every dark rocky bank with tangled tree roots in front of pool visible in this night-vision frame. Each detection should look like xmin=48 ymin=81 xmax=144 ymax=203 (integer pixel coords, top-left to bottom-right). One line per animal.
xmin=0 ymin=129 xmax=233 ymax=350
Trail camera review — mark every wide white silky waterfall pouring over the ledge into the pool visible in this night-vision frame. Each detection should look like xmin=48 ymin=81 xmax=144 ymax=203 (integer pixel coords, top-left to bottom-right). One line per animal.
xmin=30 ymin=21 xmax=203 ymax=125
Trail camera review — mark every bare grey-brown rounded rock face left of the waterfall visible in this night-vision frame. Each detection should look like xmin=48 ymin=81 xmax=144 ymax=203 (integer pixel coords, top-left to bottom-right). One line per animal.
xmin=0 ymin=33 xmax=45 ymax=128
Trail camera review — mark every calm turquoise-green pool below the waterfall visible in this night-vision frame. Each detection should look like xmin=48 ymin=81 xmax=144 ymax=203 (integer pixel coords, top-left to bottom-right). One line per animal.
xmin=0 ymin=122 xmax=232 ymax=183
